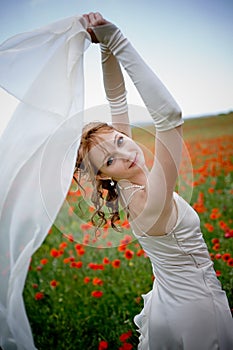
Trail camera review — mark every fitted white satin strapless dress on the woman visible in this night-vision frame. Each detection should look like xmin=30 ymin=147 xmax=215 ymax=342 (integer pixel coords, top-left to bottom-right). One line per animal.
xmin=134 ymin=193 xmax=233 ymax=350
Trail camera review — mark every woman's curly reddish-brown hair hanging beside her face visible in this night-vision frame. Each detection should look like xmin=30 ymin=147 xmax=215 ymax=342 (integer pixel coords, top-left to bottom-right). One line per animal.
xmin=74 ymin=122 xmax=120 ymax=231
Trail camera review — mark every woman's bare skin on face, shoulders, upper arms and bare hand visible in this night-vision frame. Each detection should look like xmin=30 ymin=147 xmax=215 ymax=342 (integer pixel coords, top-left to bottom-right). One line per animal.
xmin=84 ymin=13 xmax=182 ymax=236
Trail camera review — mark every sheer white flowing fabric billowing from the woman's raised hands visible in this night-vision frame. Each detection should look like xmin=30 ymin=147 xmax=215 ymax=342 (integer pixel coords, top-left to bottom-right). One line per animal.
xmin=0 ymin=16 xmax=90 ymax=350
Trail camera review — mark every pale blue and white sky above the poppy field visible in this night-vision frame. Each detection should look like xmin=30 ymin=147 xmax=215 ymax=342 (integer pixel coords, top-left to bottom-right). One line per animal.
xmin=0 ymin=0 xmax=233 ymax=132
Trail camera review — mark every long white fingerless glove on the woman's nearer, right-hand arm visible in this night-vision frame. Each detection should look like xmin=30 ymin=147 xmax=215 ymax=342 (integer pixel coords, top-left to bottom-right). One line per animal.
xmin=92 ymin=23 xmax=183 ymax=131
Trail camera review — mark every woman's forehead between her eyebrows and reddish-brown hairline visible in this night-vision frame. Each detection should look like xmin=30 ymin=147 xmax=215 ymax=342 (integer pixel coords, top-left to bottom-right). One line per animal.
xmin=89 ymin=130 xmax=119 ymax=168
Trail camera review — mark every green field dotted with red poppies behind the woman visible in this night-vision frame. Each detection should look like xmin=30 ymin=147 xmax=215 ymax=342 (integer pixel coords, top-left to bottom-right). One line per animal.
xmin=24 ymin=113 xmax=233 ymax=350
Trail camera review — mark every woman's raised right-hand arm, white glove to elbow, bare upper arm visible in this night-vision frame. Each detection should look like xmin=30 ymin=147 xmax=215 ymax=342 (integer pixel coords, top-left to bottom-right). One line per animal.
xmin=85 ymin=12 xmax=183 ymax=230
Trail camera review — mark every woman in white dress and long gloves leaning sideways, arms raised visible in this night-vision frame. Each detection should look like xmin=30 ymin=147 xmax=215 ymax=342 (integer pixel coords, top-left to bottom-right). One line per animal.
xmin=75 ymin=13 xmax=233 ymax=350
